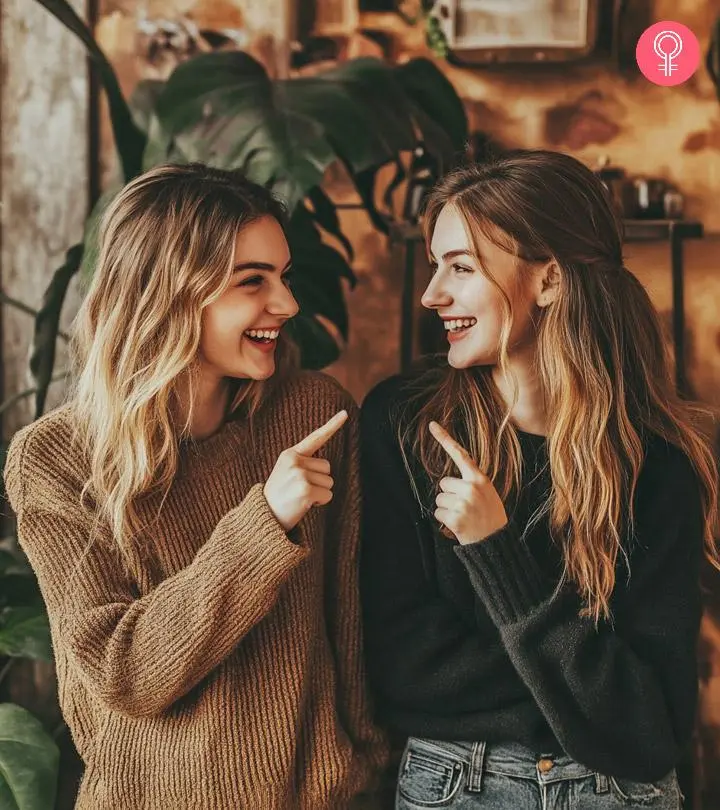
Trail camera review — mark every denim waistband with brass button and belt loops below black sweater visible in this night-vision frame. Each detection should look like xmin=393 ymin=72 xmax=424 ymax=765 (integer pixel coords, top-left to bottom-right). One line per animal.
xmin=409 ymin=737 xmax=607 ymax=792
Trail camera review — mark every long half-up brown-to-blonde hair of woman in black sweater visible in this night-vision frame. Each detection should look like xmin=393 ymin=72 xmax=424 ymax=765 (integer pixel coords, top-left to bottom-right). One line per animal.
xmin=398 ymin=150 xmax=720 ymax=622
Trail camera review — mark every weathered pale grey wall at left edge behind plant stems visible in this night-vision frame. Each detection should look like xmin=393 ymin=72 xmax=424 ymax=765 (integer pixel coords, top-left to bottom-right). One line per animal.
xmin=0 ymin=0 xmax=88 ymax=438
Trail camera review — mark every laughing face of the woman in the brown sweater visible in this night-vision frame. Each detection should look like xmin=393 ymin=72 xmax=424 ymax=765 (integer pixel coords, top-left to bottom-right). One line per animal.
xmin=200 ymin=216 xmax=298 ymax=380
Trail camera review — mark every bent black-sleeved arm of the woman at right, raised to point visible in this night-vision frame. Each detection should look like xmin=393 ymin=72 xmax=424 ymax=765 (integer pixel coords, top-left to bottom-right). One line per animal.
xmin=456 ymin=446 xmax=702 ymax=781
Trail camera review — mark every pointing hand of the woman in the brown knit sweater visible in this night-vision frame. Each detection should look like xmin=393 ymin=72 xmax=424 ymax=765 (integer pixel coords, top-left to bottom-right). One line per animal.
xmin=263 ymin=411 xmax=348 ymax=532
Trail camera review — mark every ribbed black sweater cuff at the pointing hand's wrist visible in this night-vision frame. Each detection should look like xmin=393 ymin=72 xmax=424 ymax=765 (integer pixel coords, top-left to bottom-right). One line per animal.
xmin=455 ymin=520 xmax=557 ymax=627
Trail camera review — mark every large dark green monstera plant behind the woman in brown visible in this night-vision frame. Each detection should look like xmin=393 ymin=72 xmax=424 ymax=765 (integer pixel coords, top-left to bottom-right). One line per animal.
xmin=21 ymin=0 xmax=467 ymax=415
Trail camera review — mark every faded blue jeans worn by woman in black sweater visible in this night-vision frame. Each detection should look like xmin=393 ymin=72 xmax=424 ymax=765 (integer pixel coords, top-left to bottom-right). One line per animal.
xmin=395 ymin=737 xmax=682 ymax=810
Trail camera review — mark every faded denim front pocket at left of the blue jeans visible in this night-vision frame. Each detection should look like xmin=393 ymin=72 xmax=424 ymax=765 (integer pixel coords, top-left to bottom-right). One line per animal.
xmin=397 ymin=747 xmax=463 ymax=807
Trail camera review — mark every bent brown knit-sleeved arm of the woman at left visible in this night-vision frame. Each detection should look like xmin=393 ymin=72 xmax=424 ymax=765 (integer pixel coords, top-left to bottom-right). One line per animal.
xmin=6 ymin=430 xmax=308 ymax=716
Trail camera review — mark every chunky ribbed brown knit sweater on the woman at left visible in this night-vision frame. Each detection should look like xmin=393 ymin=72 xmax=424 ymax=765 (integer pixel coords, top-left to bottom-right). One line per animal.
xmin=5 ymin=373 xmax=386 ymax=810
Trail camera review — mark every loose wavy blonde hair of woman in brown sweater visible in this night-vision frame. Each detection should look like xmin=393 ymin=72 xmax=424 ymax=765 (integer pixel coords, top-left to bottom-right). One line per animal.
xmin=70 ymin=164 xmax=296 ymax=562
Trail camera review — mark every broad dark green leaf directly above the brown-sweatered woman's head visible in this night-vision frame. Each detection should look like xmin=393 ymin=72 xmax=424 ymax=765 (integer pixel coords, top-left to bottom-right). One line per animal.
xmin=145 ymin=52 xmax=467 ymax=210
